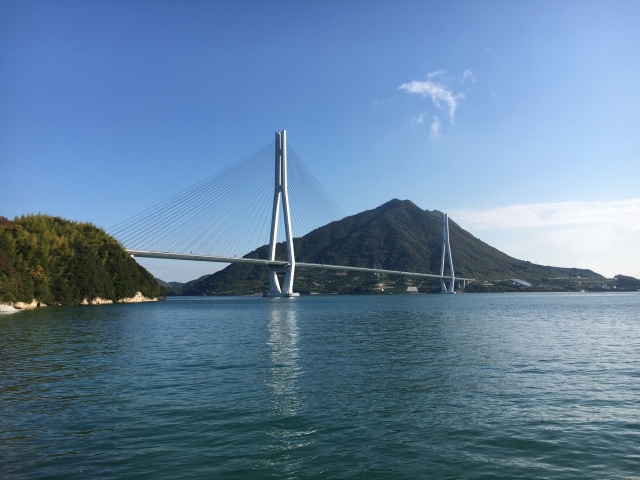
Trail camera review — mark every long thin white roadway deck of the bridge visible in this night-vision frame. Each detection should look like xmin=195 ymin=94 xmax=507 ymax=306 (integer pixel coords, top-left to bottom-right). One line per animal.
xmin=126 ymin=250 xmax=474 ymax=284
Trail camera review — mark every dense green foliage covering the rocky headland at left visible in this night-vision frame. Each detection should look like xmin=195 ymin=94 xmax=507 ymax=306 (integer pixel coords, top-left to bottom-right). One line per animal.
xmin=0 ymin=215 xmax=159 ymax=305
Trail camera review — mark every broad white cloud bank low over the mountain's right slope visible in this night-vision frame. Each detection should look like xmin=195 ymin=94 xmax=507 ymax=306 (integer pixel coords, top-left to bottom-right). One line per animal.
xmin=449 ymin=198 xmax=640 ymax=277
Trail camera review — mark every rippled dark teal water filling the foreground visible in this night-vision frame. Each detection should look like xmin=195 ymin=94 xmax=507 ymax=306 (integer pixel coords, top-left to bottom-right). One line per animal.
xmin=0 ymin=294 xmax=640 ymax=479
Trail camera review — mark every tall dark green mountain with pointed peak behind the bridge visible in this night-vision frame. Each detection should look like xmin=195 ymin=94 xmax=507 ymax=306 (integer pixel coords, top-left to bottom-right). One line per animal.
xmin=169 ymin=199 xmax=603 ymax=295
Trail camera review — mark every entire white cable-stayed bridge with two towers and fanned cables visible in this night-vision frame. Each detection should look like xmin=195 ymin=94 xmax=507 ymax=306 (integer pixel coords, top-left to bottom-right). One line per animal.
xmin=109 ymin=130 xmax=473 ymax=297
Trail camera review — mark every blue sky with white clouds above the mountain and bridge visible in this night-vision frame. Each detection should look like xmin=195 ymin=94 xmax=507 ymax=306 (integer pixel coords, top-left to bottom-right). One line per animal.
xmin=0 ymin=1 xmax=640 ymax=280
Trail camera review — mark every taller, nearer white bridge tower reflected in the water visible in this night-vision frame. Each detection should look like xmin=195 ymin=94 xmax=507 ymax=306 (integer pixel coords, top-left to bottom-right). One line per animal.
xmin=268 ymin=130 xmax=300 ymax=297
